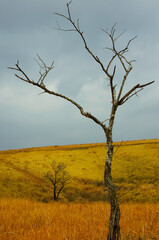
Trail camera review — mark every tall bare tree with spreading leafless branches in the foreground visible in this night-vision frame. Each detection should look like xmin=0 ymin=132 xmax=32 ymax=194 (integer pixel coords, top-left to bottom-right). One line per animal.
xmin=9 ymin=2 xmax=154 ymax=240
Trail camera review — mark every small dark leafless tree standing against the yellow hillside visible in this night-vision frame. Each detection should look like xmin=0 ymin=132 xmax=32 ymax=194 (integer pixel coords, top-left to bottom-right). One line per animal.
xmin=45 ymin=161 xmax=71 ymax=201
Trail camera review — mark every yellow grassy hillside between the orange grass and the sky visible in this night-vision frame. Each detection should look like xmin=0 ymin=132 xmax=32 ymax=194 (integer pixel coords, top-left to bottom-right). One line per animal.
xmin=0 ymin=140 xmax=159 ymax=202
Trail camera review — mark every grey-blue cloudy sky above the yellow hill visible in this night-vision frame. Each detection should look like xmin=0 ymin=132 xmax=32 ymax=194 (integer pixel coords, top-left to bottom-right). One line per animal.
xmin=0 ymin=0 xmax=159 ymax=150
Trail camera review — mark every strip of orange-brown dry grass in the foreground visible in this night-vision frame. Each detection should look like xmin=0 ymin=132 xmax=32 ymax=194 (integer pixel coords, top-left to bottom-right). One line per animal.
xmin=0 ymin=199 xmax=159 ymax=240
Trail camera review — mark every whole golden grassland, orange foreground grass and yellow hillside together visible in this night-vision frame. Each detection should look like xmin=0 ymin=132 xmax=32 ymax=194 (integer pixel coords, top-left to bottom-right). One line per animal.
xmin=0 ymin=139 xmax=159 ymax=240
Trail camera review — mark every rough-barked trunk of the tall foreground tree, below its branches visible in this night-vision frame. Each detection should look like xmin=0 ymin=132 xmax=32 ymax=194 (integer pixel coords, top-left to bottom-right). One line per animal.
xmin=104 ymin=132 xmax=120 ymax=240
